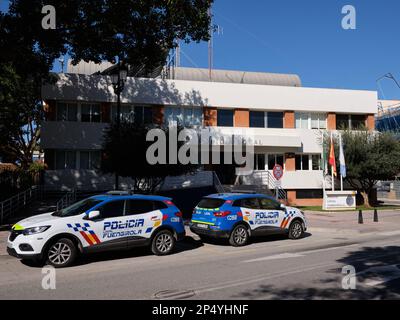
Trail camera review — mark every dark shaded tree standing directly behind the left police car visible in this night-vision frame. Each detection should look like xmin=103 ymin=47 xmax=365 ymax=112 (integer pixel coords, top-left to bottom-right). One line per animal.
xmin=101 ymin=121 xmax=199 ymax=193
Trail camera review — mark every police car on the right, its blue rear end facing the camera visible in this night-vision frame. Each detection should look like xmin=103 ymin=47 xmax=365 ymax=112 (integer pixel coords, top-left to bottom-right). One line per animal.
xmin=190 ymin=193 xmax=307 ymax=246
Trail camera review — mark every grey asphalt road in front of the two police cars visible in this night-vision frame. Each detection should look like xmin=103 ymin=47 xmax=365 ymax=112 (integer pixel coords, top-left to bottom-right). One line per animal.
xmin=0 ymin=212 xmax=400 ymax=299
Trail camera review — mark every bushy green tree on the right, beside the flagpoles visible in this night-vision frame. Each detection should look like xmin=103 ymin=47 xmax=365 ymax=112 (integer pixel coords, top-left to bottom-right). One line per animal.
xmin=324 ymin=129 xmax=400 ymax=207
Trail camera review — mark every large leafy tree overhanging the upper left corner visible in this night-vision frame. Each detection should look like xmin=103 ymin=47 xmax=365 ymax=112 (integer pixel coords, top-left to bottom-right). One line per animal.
xmin=0 ymin=0 xmax=212 ymax=169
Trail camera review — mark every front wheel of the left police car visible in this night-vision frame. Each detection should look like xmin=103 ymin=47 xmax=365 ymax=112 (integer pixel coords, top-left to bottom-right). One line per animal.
xmin=46 ymin=239 xmax=78 ymax=268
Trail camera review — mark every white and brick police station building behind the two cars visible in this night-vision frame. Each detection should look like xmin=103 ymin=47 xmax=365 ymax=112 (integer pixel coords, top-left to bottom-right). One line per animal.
xmin=41 ymin=64 xmax=377 ymax=205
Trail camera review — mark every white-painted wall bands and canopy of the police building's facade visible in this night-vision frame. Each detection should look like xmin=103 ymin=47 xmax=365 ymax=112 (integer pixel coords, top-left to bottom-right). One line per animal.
xmin=42 ymin=74 xmax=378 ymax=198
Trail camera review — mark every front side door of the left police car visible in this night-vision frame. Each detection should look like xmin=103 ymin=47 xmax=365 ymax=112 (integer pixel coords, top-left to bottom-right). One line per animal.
xmin=87 ymin=200 xmax=128 ymax=251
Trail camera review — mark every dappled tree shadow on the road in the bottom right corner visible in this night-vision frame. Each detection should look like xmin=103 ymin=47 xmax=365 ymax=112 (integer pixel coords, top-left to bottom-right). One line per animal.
xmin=234 ymin=246 xmax=400 ymax=300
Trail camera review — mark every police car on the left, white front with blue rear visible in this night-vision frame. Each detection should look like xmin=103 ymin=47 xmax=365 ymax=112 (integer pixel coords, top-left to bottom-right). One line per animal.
xmin=7 ymin=192 xmax=185 ymax=267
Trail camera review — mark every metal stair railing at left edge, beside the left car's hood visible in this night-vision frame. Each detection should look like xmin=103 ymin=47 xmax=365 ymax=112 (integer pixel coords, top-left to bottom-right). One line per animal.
xmin=0 ymin=186 xmax=43 ymax=224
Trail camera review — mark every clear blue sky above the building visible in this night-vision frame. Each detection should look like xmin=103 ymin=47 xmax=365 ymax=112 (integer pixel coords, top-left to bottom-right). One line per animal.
xmin=0 ymin=0 xmax=400 ymax=99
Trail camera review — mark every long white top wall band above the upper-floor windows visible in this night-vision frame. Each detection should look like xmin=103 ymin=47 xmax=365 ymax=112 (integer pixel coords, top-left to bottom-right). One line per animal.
xmin=42 ymin=74 xmax=377 ymax=114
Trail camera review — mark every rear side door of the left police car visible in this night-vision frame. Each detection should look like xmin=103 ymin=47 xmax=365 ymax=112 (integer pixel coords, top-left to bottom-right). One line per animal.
xmin=125 ymin=199 xmax=163 ymax=247
